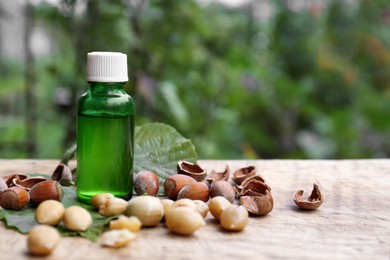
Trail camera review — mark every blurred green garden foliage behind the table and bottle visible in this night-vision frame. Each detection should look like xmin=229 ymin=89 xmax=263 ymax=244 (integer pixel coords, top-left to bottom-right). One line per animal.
xmin=0 ymin=0 xmax=390 ymax=159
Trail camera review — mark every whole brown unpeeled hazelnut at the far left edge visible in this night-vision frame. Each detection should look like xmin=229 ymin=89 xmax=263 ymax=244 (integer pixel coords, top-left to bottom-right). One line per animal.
xmin=0 ymin=186 xmax=30 ymax=210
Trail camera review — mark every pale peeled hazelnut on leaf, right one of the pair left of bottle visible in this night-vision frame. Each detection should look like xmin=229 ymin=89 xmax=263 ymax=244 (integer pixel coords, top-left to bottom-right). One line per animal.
xmin=63 ymin=206 xmax=92 ymax=231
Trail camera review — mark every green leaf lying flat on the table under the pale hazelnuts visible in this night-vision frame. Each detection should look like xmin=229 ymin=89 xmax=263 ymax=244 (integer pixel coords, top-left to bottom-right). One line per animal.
xmin=0 ymin=187 xmax=115 ymax=241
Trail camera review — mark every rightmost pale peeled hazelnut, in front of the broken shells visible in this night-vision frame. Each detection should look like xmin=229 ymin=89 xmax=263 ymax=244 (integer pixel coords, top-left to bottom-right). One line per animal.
xmin=221 ymin=205 xmax=249 ymax=231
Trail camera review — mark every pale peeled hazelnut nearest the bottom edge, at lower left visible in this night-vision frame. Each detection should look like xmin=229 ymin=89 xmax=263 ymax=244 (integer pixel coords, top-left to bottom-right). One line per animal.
xmin=27 ymin=225 xmax=61 ymax=256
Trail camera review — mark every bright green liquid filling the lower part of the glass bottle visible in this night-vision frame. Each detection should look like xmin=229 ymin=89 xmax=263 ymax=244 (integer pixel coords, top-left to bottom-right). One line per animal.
xmin=77 ymin=115 xmax=134 ymax=203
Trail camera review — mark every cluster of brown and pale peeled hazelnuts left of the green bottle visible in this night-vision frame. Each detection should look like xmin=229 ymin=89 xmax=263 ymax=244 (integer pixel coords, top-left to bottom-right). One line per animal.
xmin=0 ymin=164 xmax=92 ymax=255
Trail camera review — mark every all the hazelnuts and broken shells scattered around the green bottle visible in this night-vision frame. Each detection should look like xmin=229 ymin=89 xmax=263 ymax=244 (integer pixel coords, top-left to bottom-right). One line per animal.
xmin=0 ymin=161 xmax=323 ymax=255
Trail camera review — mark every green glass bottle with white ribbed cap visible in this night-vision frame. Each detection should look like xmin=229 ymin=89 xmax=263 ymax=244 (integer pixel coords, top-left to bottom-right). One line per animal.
xmin=76 ymin=52 xmax=134 ymax=203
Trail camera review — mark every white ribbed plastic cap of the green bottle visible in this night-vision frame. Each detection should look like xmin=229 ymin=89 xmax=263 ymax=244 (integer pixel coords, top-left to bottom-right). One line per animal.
xmin=87 ymin=52 xmax=129 ymax=82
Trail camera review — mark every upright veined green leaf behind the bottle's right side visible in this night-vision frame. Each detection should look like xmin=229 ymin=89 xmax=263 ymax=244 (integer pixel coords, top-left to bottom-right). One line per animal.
xmin=134 ymin=123 xmax=197 ymax=195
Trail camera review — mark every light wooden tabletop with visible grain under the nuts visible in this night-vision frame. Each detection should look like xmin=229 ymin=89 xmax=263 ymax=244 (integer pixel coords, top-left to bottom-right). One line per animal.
xmin=0 ymin=159 xmax=390 ymax=260
